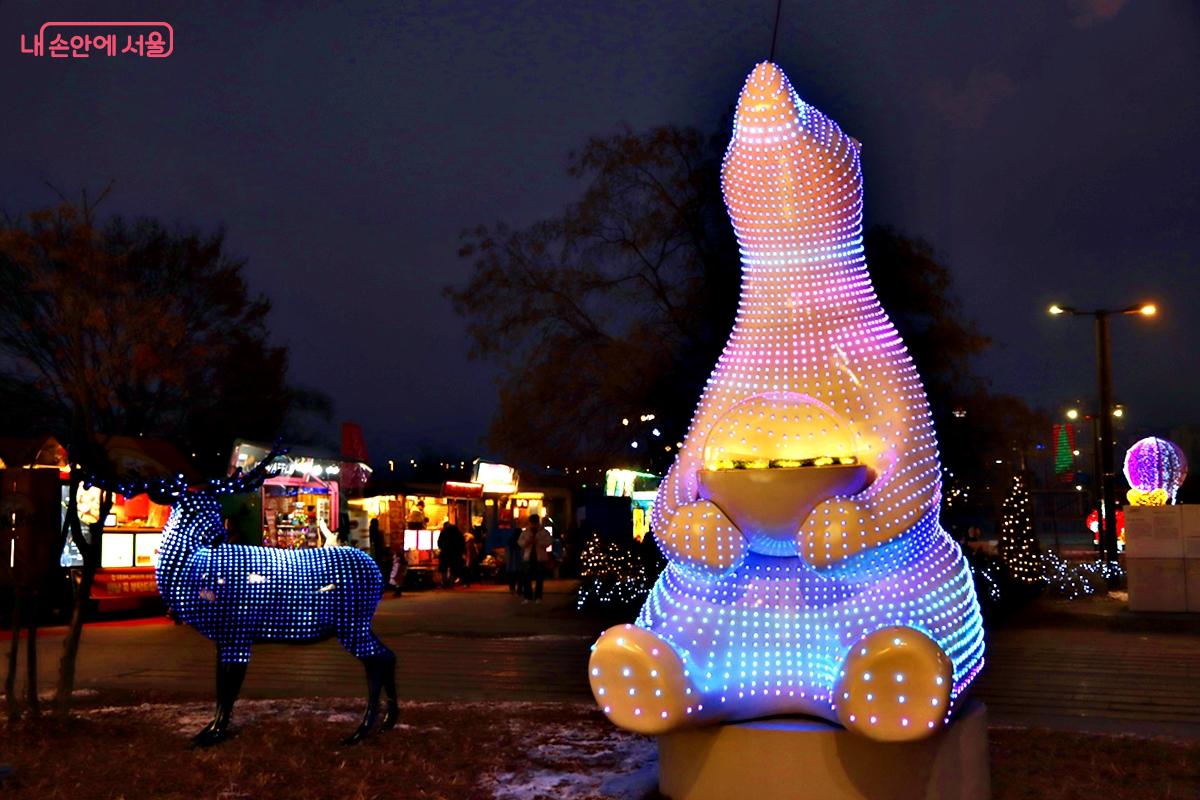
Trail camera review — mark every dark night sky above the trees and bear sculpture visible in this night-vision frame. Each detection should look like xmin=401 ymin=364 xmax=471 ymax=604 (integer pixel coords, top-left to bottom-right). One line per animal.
xmin=0 ymin=0 xmax=1200 ymax=461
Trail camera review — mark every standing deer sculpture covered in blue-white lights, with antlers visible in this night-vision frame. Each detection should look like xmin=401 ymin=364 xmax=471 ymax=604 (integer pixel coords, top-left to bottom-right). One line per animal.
xmin=89 ymin=451 xmax=398 ymax=747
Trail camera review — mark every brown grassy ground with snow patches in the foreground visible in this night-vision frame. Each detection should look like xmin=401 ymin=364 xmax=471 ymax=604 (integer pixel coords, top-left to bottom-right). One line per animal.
xmin=0 ymin=694 xmax=1200 ymax=800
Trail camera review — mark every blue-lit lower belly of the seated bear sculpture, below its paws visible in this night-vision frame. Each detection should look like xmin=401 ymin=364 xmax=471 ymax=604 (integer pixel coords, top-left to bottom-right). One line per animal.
xmin=637 ymin=513 xmax=983 ymax=702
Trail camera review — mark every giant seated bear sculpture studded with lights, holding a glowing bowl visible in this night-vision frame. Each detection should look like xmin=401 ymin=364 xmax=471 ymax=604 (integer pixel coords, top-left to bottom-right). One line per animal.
xmin=589 ymin=62 xmax=983 ymax=740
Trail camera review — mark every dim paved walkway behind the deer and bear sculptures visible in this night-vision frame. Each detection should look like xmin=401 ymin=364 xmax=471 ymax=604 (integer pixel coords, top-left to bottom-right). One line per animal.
xmin=9 ymin=582 xmax=1200 ymax=739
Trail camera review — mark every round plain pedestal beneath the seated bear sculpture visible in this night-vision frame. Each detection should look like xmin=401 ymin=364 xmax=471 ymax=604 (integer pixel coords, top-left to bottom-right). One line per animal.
xmin=659 ymin=702 xmax=990 ymax=800
